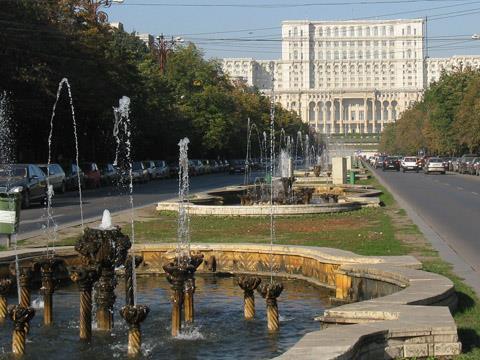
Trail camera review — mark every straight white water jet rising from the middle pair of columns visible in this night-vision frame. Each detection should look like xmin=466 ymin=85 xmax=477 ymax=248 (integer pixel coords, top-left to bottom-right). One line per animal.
xmin=177 ymin=138 xmax=190 ymax=265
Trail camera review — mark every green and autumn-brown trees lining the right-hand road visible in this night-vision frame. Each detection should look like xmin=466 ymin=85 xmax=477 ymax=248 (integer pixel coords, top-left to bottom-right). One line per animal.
xmin=380 ymin=68 xmax=480 ymax=155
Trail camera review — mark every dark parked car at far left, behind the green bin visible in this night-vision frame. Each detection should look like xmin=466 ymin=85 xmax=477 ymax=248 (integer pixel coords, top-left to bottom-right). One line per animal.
xmin=0 ymin=164 xmax=47 ymax=209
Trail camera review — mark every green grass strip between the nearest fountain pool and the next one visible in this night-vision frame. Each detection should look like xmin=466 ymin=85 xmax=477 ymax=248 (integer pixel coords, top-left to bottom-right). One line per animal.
xmin=50 ymin=172 xmax=480 ymax=359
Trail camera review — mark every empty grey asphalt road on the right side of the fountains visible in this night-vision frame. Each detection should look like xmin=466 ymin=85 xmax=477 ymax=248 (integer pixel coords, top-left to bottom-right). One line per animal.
xmin=375 ymin=170 xmax=480 ymax=286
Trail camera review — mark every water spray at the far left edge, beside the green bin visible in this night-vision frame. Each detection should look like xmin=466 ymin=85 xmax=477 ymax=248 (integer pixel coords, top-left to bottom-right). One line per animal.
xmin=0 ymin=91 xmax=20 ymax=302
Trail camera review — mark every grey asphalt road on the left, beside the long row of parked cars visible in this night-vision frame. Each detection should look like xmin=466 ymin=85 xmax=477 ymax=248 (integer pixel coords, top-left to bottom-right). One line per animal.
xmin=2 ymin=174 xmax=248 ymax=241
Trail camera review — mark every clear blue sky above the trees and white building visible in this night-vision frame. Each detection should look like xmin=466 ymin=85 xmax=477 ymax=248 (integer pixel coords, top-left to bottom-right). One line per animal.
xmin=107 ymin=0 xmax=480 ymax=59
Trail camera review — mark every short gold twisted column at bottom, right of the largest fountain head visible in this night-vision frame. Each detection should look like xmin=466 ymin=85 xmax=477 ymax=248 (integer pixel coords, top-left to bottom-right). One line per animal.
xmin=120 ymin=305 xmax=150 ymax=356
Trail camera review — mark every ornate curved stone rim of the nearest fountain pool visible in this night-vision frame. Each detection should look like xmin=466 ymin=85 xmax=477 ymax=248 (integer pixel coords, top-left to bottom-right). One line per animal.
xmin=0 ymin=244 xmax=461 ymax=359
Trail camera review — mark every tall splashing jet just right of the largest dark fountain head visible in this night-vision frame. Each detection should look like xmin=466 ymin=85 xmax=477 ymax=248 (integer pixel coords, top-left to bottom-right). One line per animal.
xmin=111 ymin=96 xmax=137 ymax=305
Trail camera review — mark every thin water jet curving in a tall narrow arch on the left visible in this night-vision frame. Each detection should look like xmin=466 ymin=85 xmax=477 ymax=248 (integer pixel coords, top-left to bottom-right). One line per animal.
xmin=45 ymin=78 xmax=84 ymax=253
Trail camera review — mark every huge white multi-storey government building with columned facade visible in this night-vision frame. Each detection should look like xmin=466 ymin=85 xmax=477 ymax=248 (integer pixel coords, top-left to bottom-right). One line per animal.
xmin=222 ymin=19 xmax=480 ymax=134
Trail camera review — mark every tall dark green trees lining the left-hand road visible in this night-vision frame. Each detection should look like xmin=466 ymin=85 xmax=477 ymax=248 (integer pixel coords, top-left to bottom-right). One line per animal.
xmin=0 ymin=0 xmax=308 ymax=161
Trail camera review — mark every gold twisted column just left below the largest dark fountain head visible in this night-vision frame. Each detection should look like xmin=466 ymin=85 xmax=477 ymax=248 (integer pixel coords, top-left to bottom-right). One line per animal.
xmin=70 ymin=267 xmax=98 ymax=341
